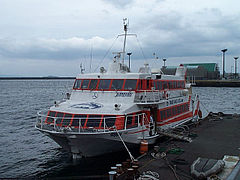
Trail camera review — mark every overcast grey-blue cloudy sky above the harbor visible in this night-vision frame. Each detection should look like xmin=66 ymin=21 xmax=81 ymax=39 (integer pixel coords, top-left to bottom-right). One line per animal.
xmin=0 ymin=0 xmax=240 ymax=76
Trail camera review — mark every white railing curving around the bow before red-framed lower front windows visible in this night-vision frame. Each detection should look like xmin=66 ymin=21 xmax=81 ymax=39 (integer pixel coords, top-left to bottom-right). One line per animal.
xmin=36 ymin=112 xmax=149 ymax=133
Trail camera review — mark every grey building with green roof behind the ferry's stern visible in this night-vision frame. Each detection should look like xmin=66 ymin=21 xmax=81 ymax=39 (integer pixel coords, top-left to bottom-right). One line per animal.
xmin=161 ymin=63 xmax=220 ymax=80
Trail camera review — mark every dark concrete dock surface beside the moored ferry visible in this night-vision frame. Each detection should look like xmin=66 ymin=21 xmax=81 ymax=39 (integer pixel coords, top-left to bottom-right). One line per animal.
xmin=118 ymin=114 xmax=240 ymax=180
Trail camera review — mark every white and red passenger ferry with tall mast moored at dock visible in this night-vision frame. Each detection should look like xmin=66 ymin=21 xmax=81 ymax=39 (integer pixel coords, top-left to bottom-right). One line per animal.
xmin=35 ymin=19 xmax=199 ymax=158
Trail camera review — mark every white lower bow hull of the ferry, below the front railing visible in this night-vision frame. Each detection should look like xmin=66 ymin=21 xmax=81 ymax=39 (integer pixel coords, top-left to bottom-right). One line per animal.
xmin=39 ymin=126 xmax=158 ymax=158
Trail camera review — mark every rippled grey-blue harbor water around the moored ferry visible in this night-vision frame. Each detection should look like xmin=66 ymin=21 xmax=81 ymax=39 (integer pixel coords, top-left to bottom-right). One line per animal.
xmin=0 ymin=80 xmax=240 ymax=178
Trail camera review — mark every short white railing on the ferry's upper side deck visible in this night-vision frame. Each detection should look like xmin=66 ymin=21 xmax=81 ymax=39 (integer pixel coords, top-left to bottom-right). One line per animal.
xmin=134 ymin=90 xmax=166 ymax=103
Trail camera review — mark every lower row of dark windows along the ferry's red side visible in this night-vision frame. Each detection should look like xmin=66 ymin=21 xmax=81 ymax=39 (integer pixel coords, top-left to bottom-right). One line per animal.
xmin=160 ymin=103 xmax=189 ymax=120
